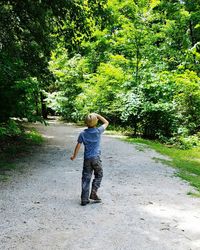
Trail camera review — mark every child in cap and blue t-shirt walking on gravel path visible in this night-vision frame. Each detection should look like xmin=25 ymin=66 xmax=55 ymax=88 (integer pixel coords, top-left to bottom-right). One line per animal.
xmin=71 ymin=113 xmax=109 ymax=206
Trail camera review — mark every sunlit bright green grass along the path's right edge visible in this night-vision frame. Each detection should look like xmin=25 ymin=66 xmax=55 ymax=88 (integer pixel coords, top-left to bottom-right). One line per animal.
xmin=125 ymin=137 xmax=200 ymax=197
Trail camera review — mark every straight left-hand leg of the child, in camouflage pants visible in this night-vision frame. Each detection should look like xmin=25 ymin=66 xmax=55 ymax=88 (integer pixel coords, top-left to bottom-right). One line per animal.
xmin=81 ymin=160 xmax=93 ymax=201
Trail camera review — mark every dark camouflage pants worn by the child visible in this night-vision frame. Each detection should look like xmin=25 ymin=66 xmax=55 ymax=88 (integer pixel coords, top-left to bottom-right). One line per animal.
xmin=81 ymin=157 xmax=103 ymax=200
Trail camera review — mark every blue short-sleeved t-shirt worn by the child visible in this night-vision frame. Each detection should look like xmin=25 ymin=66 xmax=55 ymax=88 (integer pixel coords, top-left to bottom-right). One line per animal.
xmin=78 ymin=125 xmax=105 ymax=159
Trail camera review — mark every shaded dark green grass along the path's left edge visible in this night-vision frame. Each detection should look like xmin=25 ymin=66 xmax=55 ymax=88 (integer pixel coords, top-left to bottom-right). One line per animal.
xmin=0 ymin=129 xmax=44 ymax=181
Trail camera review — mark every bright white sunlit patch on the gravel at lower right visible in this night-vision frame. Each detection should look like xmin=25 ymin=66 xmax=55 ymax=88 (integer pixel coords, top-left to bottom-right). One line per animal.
xmin=141 ymin=204 xmax=200 ymax=235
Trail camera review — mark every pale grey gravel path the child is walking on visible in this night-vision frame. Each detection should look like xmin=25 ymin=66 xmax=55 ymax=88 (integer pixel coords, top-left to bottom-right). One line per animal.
xmin=0 ymin=121 xmax=200 ymax=250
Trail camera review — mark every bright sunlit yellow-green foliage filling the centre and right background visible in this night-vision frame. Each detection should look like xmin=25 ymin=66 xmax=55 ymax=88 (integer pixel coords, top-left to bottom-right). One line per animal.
xmin=47 ymin=0 xmax=200 ymax=147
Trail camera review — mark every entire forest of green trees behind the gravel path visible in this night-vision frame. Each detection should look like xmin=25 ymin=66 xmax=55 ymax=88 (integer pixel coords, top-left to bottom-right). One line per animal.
xmin=0 ymin=0 xmax=200 ymax=148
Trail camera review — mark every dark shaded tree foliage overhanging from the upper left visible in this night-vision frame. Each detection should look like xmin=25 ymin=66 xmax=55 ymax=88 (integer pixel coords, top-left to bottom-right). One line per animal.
xmin=0 ymin=0 xmax=108 ymax=122
